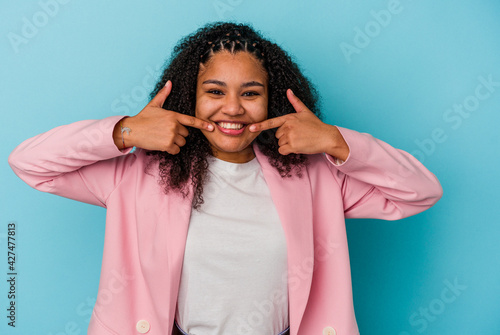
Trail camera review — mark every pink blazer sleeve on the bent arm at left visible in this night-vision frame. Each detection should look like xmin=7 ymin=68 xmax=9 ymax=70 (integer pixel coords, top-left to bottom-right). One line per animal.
xmin=9 ymin=116 xmax=135 ymax=207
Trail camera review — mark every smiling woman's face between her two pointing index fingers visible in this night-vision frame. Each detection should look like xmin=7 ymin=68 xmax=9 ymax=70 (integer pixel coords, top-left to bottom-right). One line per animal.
xmin=196 ymin=51 xmax=268 ymax=163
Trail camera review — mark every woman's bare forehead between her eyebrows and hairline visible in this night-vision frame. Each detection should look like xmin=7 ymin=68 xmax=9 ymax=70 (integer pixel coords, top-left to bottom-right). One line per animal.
xmin=198 ymin=51 xmax=267 ymax=82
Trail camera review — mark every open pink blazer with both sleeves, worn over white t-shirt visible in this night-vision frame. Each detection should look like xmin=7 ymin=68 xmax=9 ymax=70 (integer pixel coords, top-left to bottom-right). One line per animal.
xmin=9 ymin=116 xmax=442 ymax=335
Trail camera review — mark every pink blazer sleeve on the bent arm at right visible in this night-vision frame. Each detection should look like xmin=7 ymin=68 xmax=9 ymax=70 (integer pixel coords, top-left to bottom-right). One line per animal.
xmin=325 ymin=127 xmax=443 ymax=220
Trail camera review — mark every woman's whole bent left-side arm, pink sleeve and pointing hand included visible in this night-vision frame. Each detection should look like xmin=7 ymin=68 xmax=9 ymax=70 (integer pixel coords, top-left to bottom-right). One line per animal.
xmin=9 ymin=81 xmax=213 ymax=207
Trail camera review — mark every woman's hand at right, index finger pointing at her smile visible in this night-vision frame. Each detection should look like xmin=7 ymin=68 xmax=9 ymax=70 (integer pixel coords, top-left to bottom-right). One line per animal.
xmin=249 ymin=89 xmax=349 ymax=160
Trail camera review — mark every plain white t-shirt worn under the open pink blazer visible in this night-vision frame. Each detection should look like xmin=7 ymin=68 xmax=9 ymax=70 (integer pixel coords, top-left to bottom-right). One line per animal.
xmin=176 ymin=156 xmax=289 ymax=335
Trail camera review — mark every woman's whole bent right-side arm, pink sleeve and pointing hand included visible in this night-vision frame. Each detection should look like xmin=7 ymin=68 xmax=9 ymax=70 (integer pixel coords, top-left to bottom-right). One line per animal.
xmin=249 ymin=90 xmax=443 ymax=220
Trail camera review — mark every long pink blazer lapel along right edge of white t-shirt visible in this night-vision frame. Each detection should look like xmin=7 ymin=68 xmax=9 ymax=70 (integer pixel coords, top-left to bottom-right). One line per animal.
xmin=253 ymin=143 xmax=314 ymax=335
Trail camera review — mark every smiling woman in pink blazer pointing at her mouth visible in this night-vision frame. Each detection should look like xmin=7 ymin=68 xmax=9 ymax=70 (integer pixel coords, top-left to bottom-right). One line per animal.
xmin=9 ymin=23 xmax=442 ymax=335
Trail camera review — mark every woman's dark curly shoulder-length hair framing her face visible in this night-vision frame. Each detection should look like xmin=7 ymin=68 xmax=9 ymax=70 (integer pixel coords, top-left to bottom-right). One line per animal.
xmin=147 ymin=22 xmax=321 ymax=209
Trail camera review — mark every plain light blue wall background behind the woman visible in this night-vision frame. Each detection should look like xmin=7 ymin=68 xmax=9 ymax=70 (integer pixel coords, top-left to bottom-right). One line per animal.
xmin=0 ymin=0 xmax=500 ymax=335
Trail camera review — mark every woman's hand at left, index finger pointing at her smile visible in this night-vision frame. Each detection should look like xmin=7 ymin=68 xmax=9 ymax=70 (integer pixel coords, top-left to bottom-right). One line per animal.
xmin=113 ymin=80 xmax=214 ymax=155
